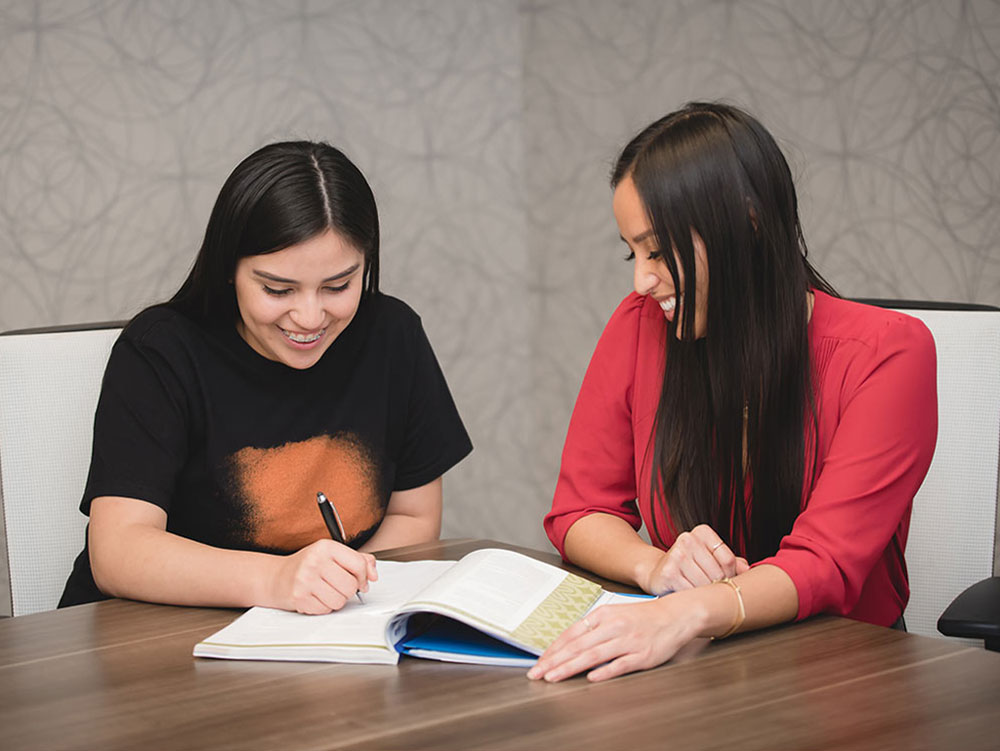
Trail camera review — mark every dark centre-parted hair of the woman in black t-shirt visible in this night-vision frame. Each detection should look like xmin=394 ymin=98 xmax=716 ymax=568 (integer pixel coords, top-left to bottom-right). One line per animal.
xmin=165 ymin=141 xmax=379 ymax=322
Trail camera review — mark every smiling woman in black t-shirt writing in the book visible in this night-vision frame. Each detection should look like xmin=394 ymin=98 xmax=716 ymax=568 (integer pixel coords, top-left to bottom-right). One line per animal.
xmin=60 ymin=142 xmax=472 ymax=613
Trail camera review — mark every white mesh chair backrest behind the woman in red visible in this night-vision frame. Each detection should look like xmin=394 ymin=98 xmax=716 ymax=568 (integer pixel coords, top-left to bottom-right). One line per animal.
xmin=880 ymin=300 xmax=1000 ymax=638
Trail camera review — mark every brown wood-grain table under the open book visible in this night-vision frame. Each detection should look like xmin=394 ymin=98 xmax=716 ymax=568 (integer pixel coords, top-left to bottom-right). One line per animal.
xmin=0 ymin=540 xmax=1000 ymax=751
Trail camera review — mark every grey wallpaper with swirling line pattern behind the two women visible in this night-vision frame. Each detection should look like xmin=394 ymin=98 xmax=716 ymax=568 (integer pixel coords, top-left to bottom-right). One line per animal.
xmin=0 ymin=0 xmax=1000 ymax=545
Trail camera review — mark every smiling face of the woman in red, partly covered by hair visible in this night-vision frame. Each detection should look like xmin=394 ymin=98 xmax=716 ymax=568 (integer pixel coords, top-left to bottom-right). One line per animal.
xmin=612 ymin=175 xmax=708 ymax=339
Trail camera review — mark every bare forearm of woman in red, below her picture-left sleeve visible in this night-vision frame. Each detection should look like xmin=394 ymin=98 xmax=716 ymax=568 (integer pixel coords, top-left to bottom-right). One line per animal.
xmin=564 ymin=514 xmax=664 ymax=591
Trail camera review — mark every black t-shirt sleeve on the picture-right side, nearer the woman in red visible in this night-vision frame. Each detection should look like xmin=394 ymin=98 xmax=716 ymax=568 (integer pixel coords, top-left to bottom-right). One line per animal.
xmin=393 ymin=319 xmax=472 ymax=490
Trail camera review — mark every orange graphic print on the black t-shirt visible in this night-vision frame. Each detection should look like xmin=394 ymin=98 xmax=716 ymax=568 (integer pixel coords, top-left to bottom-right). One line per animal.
xmin=230 ymin=433 xmax=385 ymax=552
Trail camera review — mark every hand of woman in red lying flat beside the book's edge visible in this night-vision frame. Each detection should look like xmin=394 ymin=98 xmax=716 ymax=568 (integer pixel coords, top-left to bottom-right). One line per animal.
xmin=528 ymin=594 xmax=699 ymax=681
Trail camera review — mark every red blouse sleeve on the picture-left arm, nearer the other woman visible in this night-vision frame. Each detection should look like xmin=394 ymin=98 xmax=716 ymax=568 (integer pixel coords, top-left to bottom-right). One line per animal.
xmin=544 ymin=293 xmax=645 ymax=557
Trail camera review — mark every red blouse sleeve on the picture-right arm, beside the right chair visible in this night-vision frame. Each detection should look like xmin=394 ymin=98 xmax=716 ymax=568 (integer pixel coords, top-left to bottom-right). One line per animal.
xmin=760 ymin=316 xmax=937 ymax=619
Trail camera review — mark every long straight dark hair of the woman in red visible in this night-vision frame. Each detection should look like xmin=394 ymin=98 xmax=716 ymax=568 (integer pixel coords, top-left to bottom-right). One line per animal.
xmin=611 ymin=102 xmax=835 ymax=561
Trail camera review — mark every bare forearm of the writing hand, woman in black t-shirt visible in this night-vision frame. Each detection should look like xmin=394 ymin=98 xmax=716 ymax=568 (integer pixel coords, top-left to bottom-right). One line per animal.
xmin=90 ymin=525 xmax=281 ymax=607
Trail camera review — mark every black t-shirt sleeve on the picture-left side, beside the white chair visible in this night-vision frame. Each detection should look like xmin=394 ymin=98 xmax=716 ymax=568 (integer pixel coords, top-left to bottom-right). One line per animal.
xmin=80 ymin=318 xmax=188 ymax=515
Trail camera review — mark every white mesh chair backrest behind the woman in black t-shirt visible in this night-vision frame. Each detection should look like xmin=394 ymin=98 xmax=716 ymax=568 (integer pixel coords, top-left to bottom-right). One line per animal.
xmin=0 ymin=322 xmax=122 ymax=616
